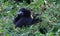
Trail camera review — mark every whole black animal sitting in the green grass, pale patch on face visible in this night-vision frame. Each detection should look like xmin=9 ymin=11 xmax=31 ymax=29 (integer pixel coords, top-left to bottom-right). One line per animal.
xmin=14 ymin=8 xmax=42 ymax=28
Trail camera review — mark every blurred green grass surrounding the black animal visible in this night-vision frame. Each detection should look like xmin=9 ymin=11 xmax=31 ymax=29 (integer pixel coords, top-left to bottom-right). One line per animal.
xmin=0 ymin=0 xmax=60 ymax=36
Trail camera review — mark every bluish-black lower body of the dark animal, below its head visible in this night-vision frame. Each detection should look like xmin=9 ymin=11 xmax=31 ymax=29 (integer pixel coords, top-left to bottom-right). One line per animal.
xmin=15 ymin=17 xmax=32 ymax=28
